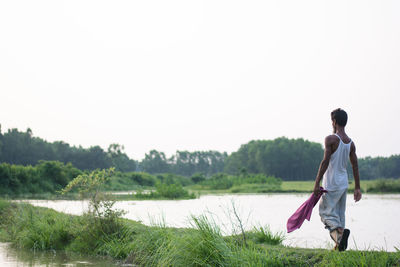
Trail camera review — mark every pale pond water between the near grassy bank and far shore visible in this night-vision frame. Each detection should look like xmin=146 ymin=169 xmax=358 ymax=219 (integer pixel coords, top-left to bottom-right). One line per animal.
xmin=25 ymin=194 xmax=400 ymax=251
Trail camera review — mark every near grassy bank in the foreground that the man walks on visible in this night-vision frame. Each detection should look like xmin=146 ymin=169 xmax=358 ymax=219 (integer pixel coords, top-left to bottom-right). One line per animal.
xmin=0 ymin=201 xmax=400 ymax=266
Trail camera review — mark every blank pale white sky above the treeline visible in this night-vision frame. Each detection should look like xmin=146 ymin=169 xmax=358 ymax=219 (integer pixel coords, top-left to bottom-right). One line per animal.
xmin=0 ymin=0 xmax=400 ymax=160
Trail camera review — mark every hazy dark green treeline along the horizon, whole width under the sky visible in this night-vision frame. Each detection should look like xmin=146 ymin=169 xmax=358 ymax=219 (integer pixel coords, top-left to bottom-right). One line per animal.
xmin=0 ymin=127 xmax=400 ymax=180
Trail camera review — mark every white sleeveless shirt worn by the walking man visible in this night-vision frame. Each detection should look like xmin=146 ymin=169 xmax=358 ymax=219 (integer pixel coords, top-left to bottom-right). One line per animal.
xmin=322 ymin=134 xmax=352 ymax=191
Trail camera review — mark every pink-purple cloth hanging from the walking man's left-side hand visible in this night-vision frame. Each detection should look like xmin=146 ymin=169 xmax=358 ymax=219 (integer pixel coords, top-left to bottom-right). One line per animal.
xmin=286 ymin=187 xmax=328 ymax=233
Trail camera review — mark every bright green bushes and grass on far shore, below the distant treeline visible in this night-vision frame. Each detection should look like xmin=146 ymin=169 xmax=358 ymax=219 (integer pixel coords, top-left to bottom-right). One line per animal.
xmin=0 ymin=161 xmax=400 ymax=200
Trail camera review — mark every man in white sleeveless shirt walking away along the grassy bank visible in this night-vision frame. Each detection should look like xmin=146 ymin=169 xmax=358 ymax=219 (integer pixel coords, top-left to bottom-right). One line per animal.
xmin=314 ymin=108 xmax=361 ymax=251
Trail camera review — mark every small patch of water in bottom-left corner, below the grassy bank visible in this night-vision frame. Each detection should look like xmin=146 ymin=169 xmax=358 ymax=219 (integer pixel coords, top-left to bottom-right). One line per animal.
xmin=0 ymin=243 xmax=118 ymax=267
